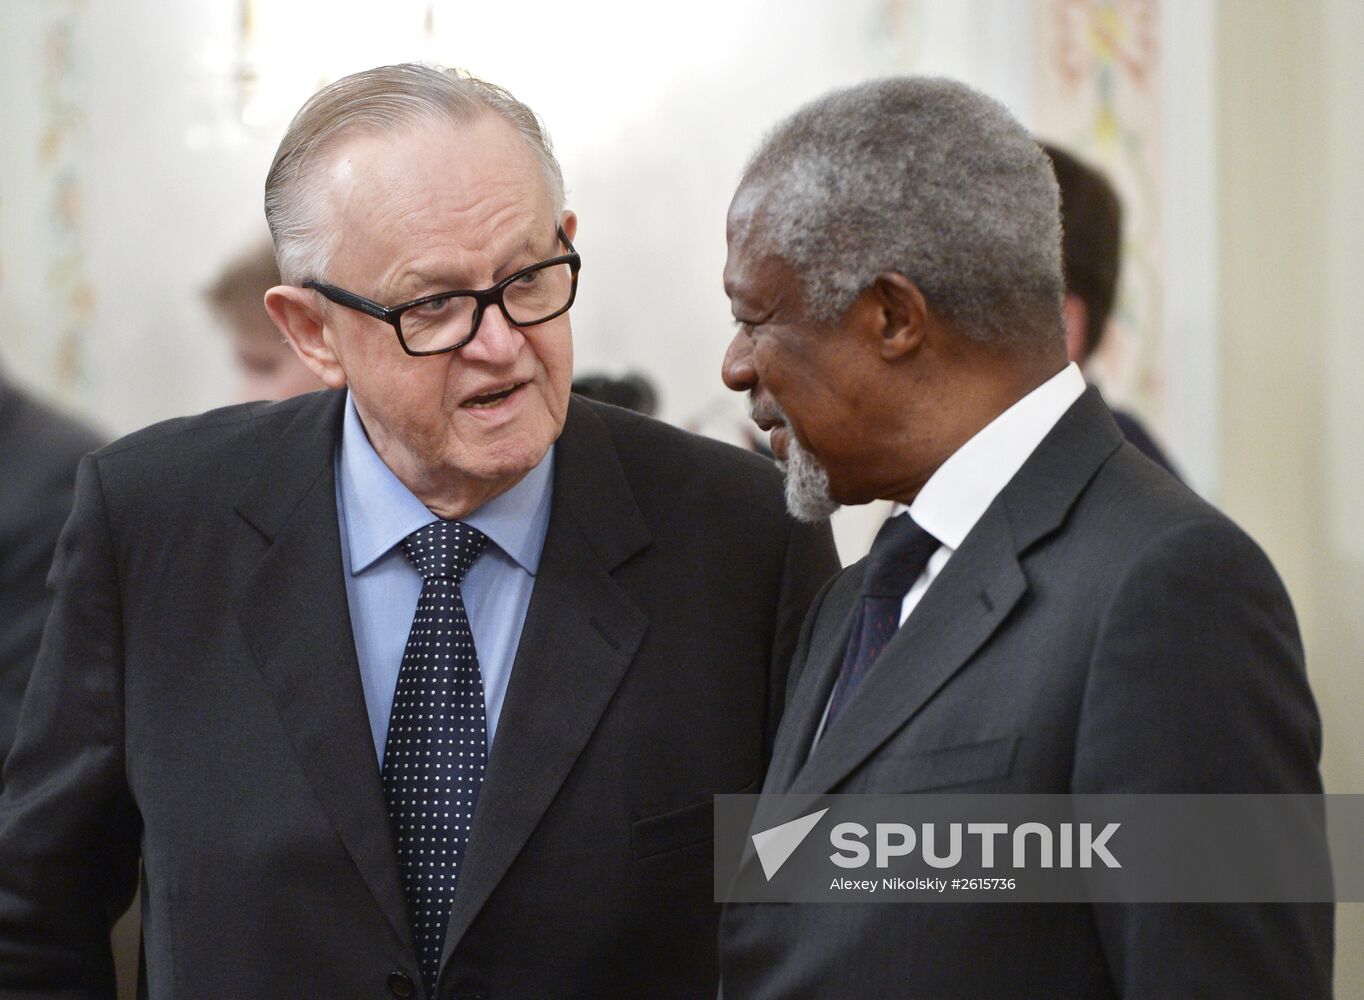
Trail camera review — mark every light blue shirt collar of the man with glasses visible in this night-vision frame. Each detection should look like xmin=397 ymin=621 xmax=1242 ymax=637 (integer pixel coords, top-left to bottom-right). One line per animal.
xmin=337 ymin=393 xmax=554 ymax=576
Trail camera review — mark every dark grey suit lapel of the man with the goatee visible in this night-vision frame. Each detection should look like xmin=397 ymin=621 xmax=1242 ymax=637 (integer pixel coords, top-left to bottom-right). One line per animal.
xmin=786 ymin=389 xmax=1121 ymax=794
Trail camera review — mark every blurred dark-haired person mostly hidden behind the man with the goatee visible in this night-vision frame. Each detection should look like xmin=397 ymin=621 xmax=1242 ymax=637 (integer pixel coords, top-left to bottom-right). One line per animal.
xmin=1041 ymin=142 xmax=1178 ymax=477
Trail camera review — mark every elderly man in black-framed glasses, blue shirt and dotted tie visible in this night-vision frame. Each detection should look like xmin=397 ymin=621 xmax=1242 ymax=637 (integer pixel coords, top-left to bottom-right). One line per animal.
xmin=0 ymin=65 xmax=836 ymax=999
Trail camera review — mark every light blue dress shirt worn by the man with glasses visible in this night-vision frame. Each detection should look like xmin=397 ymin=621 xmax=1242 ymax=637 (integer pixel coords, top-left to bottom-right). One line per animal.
xmin=336 ymin=396 xmax=554 ymax=768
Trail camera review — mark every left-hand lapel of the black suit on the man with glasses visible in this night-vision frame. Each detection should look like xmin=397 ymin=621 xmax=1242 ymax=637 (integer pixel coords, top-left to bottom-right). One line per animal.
xmin=237 ymin=393 xmax=412 ymax=948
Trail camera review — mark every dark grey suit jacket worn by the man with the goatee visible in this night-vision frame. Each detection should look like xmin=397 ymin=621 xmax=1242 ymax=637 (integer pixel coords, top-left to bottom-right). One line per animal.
xmin=722 ymin=389 xmax=1331 ymax=1000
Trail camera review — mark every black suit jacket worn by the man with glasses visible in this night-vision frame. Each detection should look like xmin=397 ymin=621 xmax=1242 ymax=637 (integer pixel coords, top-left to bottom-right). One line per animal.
xmin=0 ymin=393 xmax=836 ymax=1000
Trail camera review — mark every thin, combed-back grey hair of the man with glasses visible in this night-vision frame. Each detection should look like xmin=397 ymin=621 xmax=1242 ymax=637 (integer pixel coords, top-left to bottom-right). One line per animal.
xmin=265 ymin=63 xmax=563 ymax=284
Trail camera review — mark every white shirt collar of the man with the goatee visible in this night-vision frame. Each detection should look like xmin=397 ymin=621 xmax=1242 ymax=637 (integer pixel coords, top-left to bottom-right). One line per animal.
xmin=893 ymin=364 xmax=1084 ymax=550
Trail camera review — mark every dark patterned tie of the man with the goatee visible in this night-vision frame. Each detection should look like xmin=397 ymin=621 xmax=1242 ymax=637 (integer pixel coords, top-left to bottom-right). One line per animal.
xmin=824 ymin=512 xmax=938 ymax=729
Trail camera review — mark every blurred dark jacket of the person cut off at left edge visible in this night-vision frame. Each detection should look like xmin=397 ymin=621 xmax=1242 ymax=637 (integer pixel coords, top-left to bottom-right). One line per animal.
xmin=0 ymin=377 xmax=104 ymax=765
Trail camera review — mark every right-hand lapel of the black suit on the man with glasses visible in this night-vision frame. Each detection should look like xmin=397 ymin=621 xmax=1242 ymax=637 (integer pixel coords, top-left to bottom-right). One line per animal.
xmin=443 ymin=400 xmax=649 ymax=960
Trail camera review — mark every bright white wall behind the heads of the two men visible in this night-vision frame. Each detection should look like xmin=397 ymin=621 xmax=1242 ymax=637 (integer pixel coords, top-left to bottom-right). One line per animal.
xmin=0 ymin=0 xmax=1031 ymax=558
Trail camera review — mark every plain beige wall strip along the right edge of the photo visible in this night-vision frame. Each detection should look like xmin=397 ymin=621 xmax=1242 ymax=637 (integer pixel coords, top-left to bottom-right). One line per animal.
xmin=1217 ymin=0 xmax=1364 ymax=997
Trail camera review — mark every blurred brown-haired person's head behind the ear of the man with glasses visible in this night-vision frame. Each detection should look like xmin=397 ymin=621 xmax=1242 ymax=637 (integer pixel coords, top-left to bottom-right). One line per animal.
xmin=205 ymin=240 xmax=325 ymax=402
